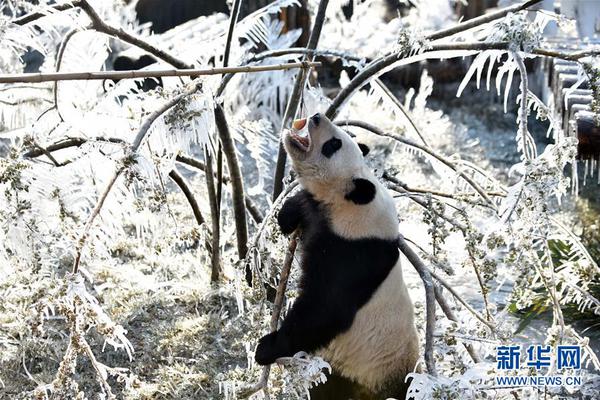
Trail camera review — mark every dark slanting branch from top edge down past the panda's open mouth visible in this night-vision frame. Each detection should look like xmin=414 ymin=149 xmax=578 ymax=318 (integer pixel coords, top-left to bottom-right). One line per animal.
xmin=272 ymin=0 xmax=329 ymax=200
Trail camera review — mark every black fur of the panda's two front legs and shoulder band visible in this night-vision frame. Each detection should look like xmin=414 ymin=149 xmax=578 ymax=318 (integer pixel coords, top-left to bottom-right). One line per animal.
xmin=255 ymin=190 xmax=399 ymax=365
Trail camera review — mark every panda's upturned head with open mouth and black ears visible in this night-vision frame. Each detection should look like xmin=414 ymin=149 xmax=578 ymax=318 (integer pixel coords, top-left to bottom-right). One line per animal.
xmin=283 ymin=114 xmax=377 ymax=205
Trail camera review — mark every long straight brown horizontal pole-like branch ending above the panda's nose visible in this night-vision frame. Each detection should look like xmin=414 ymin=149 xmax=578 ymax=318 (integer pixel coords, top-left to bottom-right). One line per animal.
xmin=0 ymin=61 xmax=321 ymax=83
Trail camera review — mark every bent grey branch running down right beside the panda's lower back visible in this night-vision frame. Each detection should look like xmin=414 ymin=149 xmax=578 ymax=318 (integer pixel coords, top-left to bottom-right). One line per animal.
xmin=398 ymin=235 xmax=437 ymax=376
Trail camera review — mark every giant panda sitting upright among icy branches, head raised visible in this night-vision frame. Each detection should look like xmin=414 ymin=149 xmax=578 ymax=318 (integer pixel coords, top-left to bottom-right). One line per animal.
xmin=255 ymin=114 xmax=419 ymax=400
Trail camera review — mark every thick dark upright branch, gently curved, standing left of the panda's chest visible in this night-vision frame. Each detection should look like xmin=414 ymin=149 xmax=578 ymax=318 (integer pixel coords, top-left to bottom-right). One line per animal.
xmin=214 ymin=103 xmax=248 ymax=259
